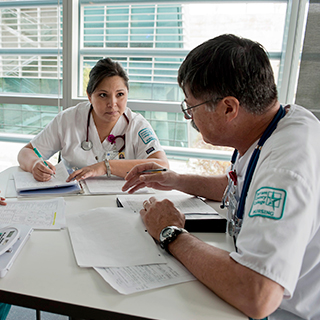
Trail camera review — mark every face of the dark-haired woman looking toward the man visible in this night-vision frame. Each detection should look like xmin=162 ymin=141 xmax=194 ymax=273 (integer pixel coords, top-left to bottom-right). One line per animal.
xmin=88 ymin=76 xmax=128 ymax=125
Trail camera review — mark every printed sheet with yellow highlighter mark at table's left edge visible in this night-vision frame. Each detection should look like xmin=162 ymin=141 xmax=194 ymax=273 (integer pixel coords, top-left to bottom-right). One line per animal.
xmin=0 ymin=198 xmax=66 ymax=229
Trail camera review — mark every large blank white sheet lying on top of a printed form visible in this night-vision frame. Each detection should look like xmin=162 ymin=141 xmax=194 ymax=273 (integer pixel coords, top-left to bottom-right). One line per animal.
xmin=67 ymin=207 xmax=166 ymax=267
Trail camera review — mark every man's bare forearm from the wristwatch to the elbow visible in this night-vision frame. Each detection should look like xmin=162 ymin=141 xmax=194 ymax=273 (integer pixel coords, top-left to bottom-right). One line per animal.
xmin=168 ymin=234 xmax=283 ymax=319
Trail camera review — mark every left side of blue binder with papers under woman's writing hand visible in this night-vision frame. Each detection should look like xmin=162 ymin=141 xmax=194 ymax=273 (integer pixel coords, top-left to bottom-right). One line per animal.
xmin=13 ymin=162 xmax=81 ymax=196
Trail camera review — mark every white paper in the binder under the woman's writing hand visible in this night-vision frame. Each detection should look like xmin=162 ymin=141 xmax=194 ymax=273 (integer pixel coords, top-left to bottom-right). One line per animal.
xmin=13 ymin=162 xmax=78 ymax=191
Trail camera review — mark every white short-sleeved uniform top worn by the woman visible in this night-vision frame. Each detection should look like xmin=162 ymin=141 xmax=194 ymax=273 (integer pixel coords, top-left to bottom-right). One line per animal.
xmin=31 ymin=102 xmax=163 ymax=168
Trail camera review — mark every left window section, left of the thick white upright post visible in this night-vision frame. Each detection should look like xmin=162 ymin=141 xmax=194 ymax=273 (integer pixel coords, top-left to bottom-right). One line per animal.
xmin=0 ymin=1 xmax=62 ymax=135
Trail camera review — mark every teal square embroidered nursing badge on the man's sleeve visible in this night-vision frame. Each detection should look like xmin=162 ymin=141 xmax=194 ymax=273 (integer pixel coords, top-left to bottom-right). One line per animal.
xmin=249 ymin=187 xmax=287 ymax=220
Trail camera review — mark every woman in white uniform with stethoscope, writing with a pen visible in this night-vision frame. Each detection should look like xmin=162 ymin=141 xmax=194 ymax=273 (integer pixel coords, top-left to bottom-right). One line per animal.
xmin=18 ymin=58 xmax=168 ymax=181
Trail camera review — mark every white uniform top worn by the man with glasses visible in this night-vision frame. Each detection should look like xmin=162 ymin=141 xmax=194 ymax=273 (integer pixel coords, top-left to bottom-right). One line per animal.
xmin=230 ymin=105 xmax=320 ymax=320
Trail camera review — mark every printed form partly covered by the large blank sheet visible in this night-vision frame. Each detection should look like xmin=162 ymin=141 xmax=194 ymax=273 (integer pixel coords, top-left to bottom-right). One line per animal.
xmin=94 ymin=252 xmax=196 ymax=294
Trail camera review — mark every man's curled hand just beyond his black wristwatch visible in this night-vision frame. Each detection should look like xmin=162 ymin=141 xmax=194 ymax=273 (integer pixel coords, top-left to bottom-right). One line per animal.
xmin=140 ymin=197 xmax=185 ymax=240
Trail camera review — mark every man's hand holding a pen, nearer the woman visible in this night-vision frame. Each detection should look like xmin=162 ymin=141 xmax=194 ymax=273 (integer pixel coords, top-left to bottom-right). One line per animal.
xmin=122 ymin=162 xmax=179 ymax=193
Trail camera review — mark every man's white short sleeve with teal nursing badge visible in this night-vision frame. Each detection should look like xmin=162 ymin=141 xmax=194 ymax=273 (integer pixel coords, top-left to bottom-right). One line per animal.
xmin=230 ymin=168 xmax=317 ymax=298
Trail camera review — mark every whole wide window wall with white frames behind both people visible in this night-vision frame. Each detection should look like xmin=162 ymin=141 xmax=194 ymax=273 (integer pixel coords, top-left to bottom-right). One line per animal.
xmin=0 ymin=0 xmax=306 ymax=164
